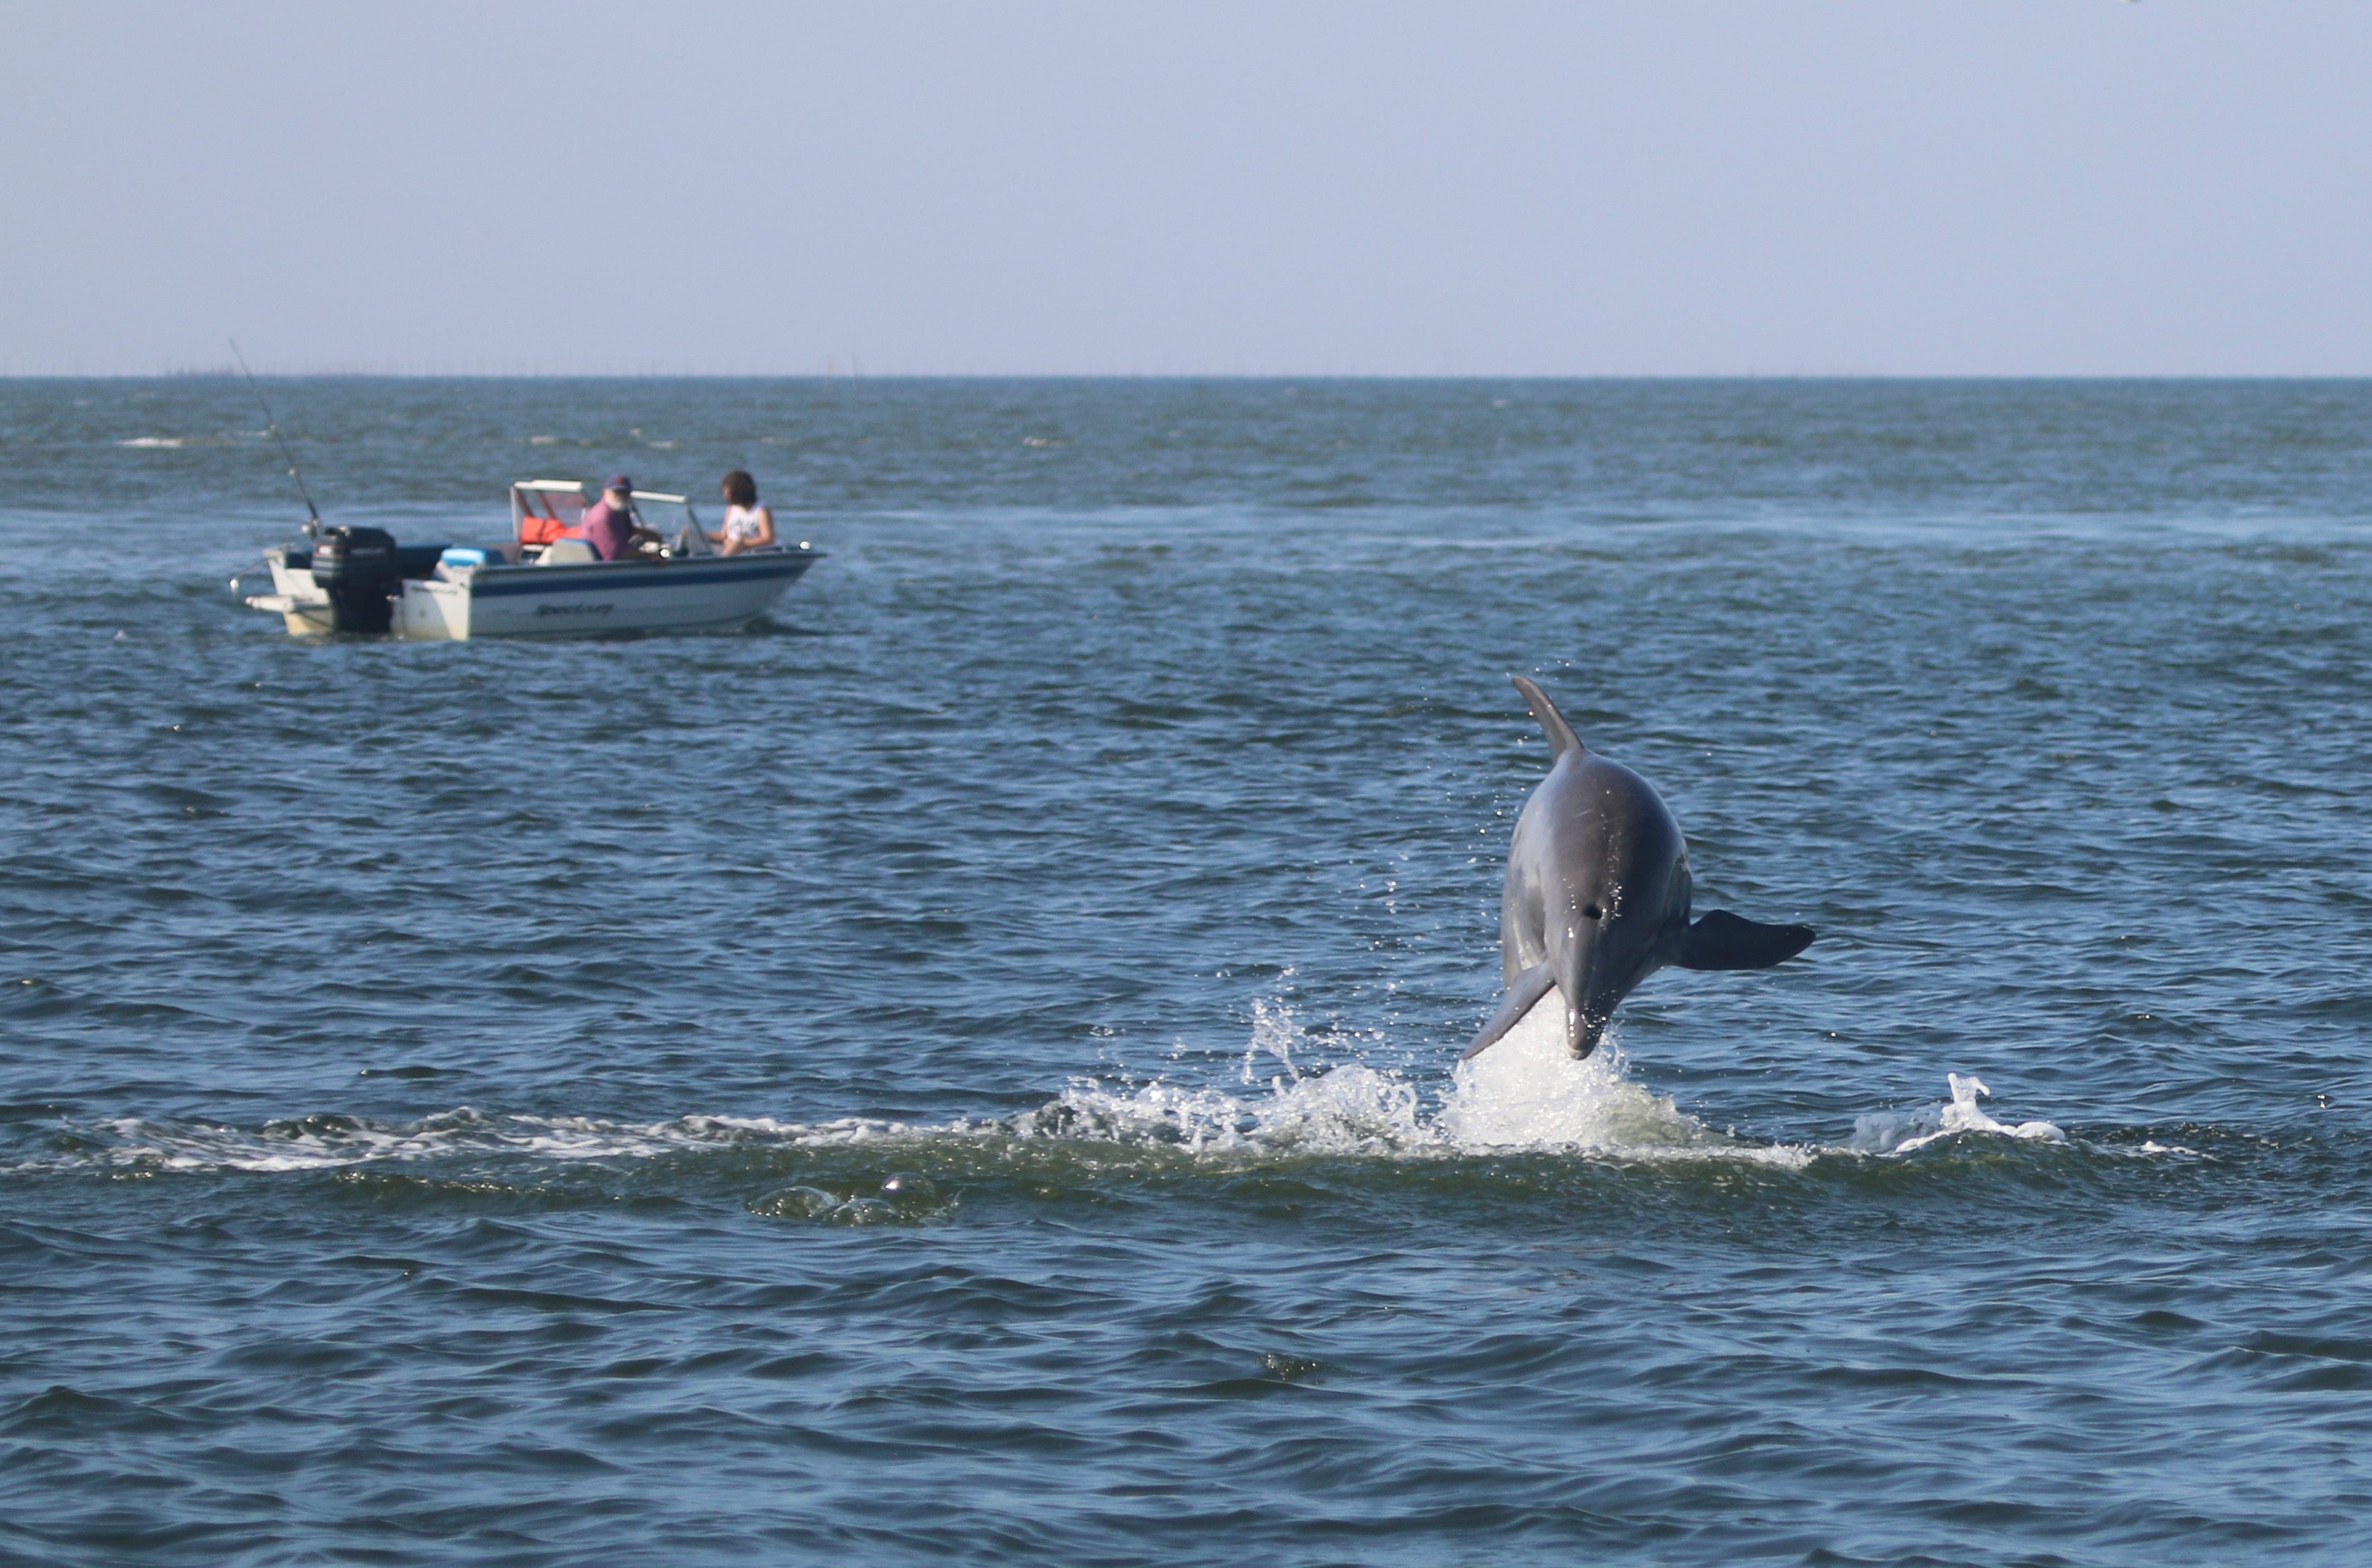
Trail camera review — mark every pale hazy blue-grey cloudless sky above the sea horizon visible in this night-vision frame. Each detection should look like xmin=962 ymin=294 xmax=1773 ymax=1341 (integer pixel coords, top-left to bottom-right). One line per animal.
xmin=0 ymin=0 xmax=2372 ymax=375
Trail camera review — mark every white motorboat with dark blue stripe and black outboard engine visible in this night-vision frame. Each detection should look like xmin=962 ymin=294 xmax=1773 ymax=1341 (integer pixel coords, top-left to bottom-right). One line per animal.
xmin=230 ymin=479 xmax=823 ymax=643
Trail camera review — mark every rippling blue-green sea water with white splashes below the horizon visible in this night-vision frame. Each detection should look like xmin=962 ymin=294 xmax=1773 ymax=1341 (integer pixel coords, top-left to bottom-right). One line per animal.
xmin=0 ymin=377 xmax=2372 ymax=1568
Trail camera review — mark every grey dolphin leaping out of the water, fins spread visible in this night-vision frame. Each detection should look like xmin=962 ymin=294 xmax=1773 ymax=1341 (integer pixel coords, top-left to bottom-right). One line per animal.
xmin=1459 ymin=676 xmax=1812 ymax=1060
